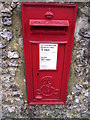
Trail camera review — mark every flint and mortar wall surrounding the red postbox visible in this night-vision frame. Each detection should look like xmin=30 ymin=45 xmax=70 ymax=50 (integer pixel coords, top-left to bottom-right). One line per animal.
xmin=0 ymin=0 xmax=90 ymax=119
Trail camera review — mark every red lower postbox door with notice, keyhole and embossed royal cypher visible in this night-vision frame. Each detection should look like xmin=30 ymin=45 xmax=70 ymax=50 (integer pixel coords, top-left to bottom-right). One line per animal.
xmin=31 ymin=42 xmax=66 ymax=100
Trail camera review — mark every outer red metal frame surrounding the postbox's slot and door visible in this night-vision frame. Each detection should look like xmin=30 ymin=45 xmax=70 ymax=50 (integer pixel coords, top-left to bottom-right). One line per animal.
xmin=21 ymin=2 xmax=77 ymax=105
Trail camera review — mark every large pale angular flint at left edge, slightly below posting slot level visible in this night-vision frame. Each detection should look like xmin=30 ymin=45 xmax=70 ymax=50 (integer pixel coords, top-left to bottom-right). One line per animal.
xmin=0 ymin=28 xmax=13 ymax=41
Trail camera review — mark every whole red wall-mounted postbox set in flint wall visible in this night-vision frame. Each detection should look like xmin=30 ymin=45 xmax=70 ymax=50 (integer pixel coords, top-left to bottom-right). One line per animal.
xmin=21 ymin=2 xmax=77 ymax=104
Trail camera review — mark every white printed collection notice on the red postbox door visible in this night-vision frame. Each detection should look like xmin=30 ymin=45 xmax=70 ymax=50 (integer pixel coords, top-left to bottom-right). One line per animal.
xmin=39 ymin=43 xmax=58 ymax=70
